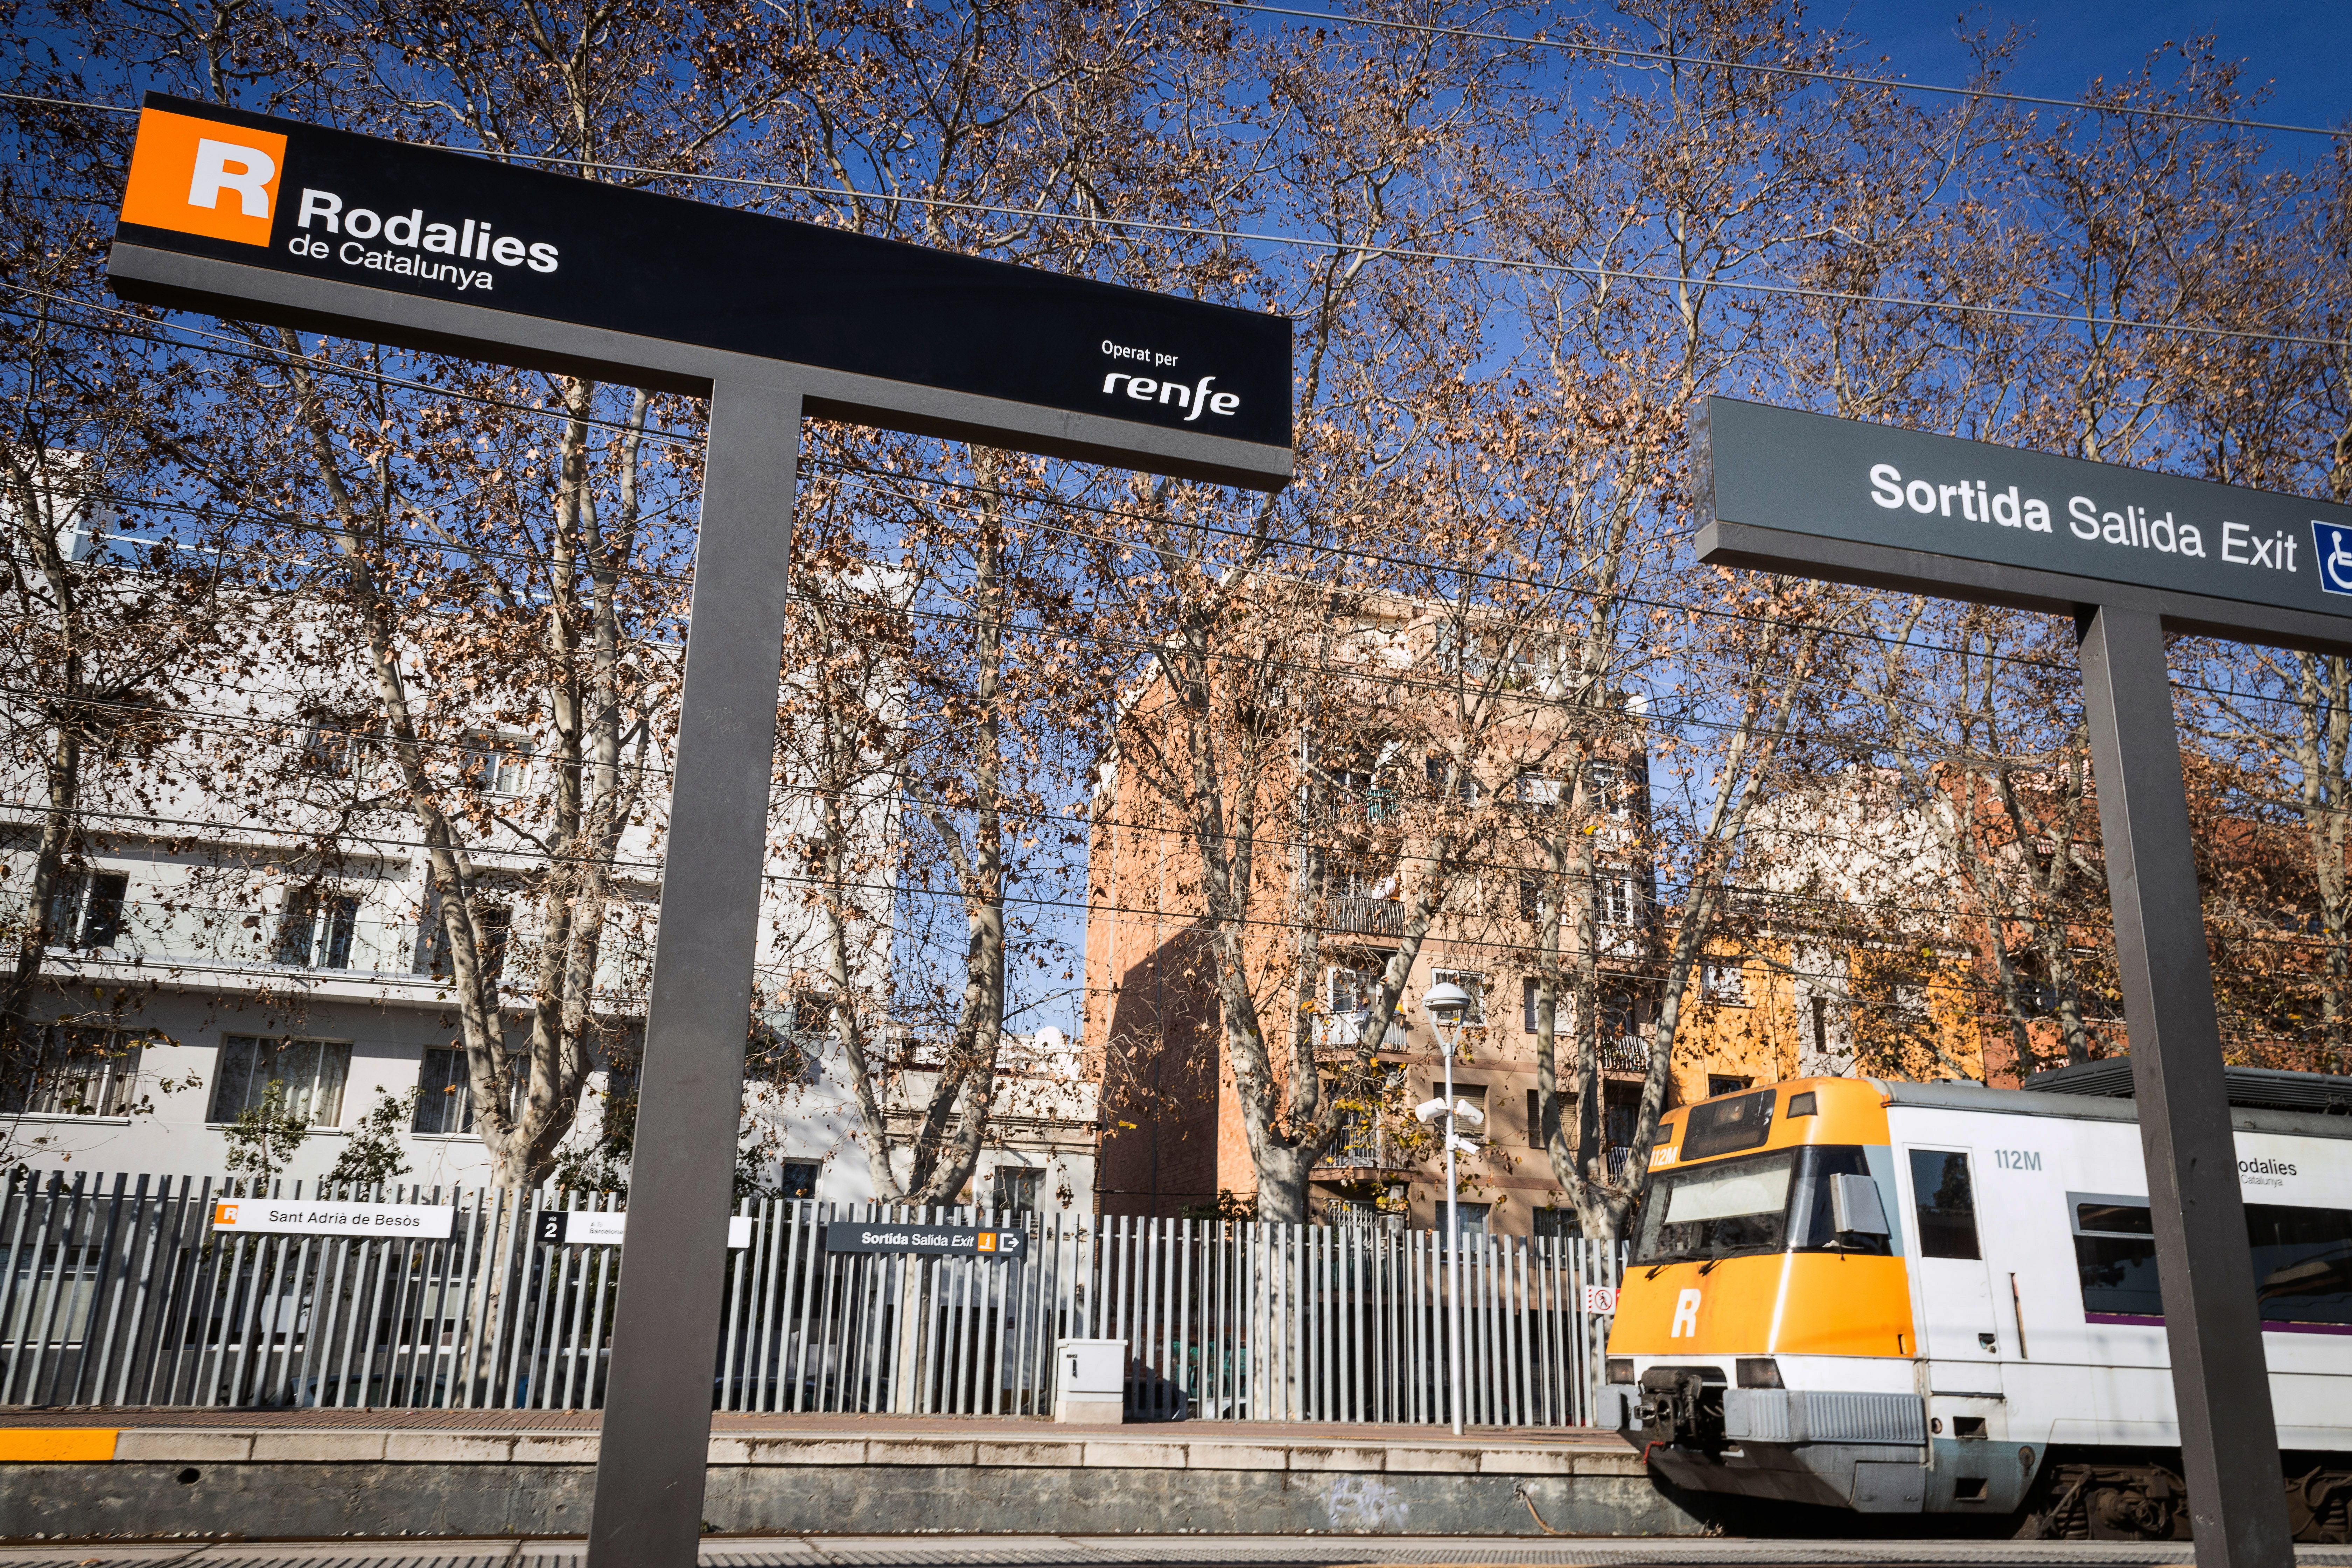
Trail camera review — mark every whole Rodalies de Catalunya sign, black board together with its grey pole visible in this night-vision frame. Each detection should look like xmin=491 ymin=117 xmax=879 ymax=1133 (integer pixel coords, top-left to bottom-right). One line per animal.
xmin=106 ymin=96 xmax=1291 ymax=1568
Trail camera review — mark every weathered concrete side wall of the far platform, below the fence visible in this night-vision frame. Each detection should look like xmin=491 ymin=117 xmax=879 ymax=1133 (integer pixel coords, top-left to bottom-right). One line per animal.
xmin=0 ymin=1434 xmax=1708 ymax=1542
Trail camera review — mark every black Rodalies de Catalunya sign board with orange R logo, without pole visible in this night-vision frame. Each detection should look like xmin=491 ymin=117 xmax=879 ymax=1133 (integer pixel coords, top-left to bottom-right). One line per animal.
xmin=115 ymin=94 xmax=1291 ymax=463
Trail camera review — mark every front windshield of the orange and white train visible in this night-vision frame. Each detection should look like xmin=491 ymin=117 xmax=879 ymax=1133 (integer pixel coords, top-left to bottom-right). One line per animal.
xmin=1632 ymin=1145 xmax=1891 ymax=1265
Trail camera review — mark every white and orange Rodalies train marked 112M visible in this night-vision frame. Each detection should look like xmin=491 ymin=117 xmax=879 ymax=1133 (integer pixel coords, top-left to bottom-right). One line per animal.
xmin=1597 ymin=1072 xmax=2352 ymax=1540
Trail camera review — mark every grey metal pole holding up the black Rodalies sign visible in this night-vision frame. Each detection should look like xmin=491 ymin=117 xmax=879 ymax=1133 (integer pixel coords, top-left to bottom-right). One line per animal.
xmin=588 ymin=381 xmax=800 ymax=1568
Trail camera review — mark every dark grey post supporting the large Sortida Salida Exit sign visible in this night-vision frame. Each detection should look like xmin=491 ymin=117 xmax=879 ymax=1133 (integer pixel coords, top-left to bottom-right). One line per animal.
xmin=2077 ymin=604 xmax=2296 ymax=1568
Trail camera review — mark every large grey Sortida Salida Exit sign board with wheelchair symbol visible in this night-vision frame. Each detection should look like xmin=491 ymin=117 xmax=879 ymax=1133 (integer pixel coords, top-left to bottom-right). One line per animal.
xmin=1696 ymin=397 xmax=2352 ymax=616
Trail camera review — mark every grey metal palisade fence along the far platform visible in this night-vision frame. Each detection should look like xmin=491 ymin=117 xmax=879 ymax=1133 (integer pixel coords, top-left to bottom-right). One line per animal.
xmin=0 ymin=1173 xmax=1618 ymax=1427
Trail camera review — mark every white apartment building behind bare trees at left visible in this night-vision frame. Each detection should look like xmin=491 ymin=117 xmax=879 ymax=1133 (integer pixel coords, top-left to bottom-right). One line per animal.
xmin=0 ymin=503 xmax=1098 ymax=1211
